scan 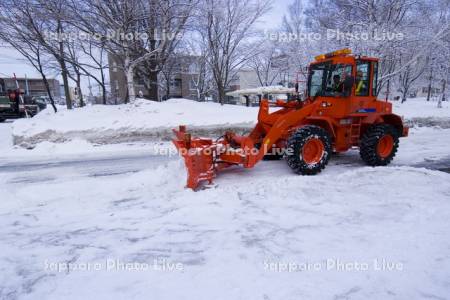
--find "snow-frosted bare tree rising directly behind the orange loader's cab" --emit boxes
[307,0,444,92]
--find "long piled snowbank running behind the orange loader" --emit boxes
[13,99,450,147]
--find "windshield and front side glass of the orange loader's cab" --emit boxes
[308,63,352,97]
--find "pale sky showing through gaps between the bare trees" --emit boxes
[0,0,292,93]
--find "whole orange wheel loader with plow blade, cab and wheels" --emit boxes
[173,49,408,189]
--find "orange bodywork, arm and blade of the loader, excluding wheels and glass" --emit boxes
[173,50,408,189]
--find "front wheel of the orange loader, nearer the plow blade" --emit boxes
[286,125,332,175]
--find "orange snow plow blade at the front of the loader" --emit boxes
[172,126,216,190]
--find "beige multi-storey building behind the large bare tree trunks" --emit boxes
[108,54,198,103]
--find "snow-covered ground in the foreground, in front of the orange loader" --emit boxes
[0,145,450,300]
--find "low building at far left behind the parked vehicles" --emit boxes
[0,78,61,99]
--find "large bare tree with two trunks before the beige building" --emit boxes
[72,0,196,101]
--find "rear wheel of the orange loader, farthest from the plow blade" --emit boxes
[359,124,399,166]
